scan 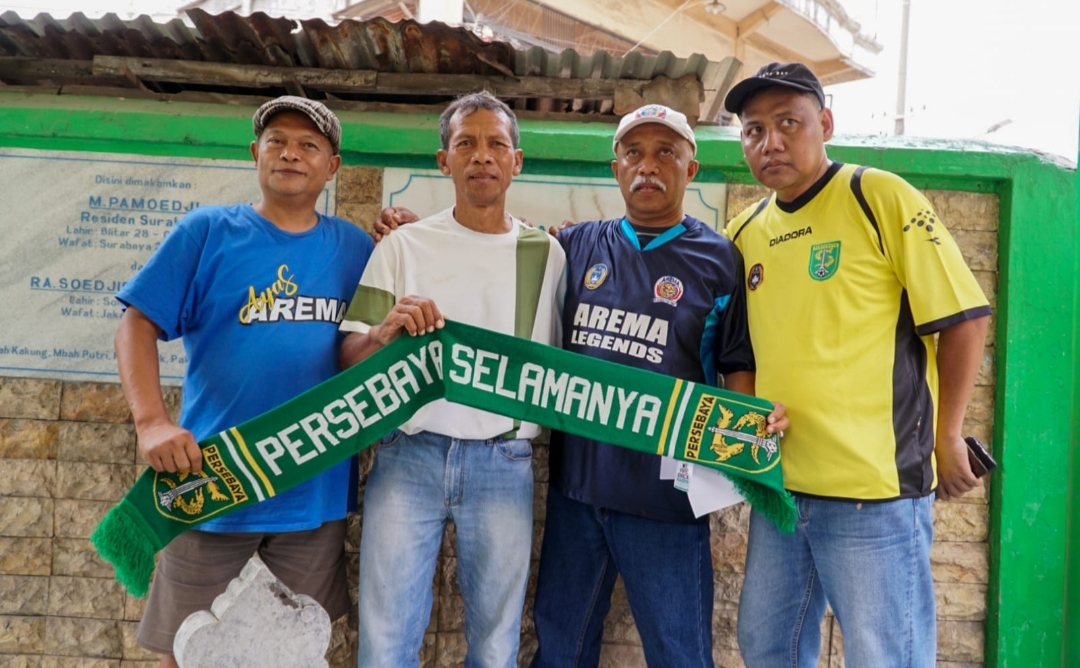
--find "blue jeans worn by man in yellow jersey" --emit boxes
[739,494,937,668]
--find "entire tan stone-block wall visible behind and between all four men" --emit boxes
[0,167,999,668]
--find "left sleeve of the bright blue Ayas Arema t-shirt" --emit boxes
[117,209,211,341]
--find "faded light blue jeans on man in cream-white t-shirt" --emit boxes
[356,431,532,668]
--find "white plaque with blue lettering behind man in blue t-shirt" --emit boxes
[0,148,335,384]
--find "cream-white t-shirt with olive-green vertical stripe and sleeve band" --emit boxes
[341,208,566,439]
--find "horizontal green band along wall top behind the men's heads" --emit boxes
[0,92,1065,186]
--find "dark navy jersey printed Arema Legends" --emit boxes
[551,216,754,522]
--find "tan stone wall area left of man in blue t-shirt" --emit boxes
[0,378,179,668]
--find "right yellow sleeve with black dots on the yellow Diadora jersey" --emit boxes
[856,169,990,336]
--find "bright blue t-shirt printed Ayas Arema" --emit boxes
[117,204,374,532]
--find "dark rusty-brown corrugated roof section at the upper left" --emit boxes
[0,9,513,73]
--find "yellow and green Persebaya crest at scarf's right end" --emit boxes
[686,394,780,471]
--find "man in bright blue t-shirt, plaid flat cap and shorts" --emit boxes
[116,96,373,668]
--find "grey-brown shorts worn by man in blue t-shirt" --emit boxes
[135,519,351,655]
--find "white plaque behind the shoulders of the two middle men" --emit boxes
[382,168,727,230]
